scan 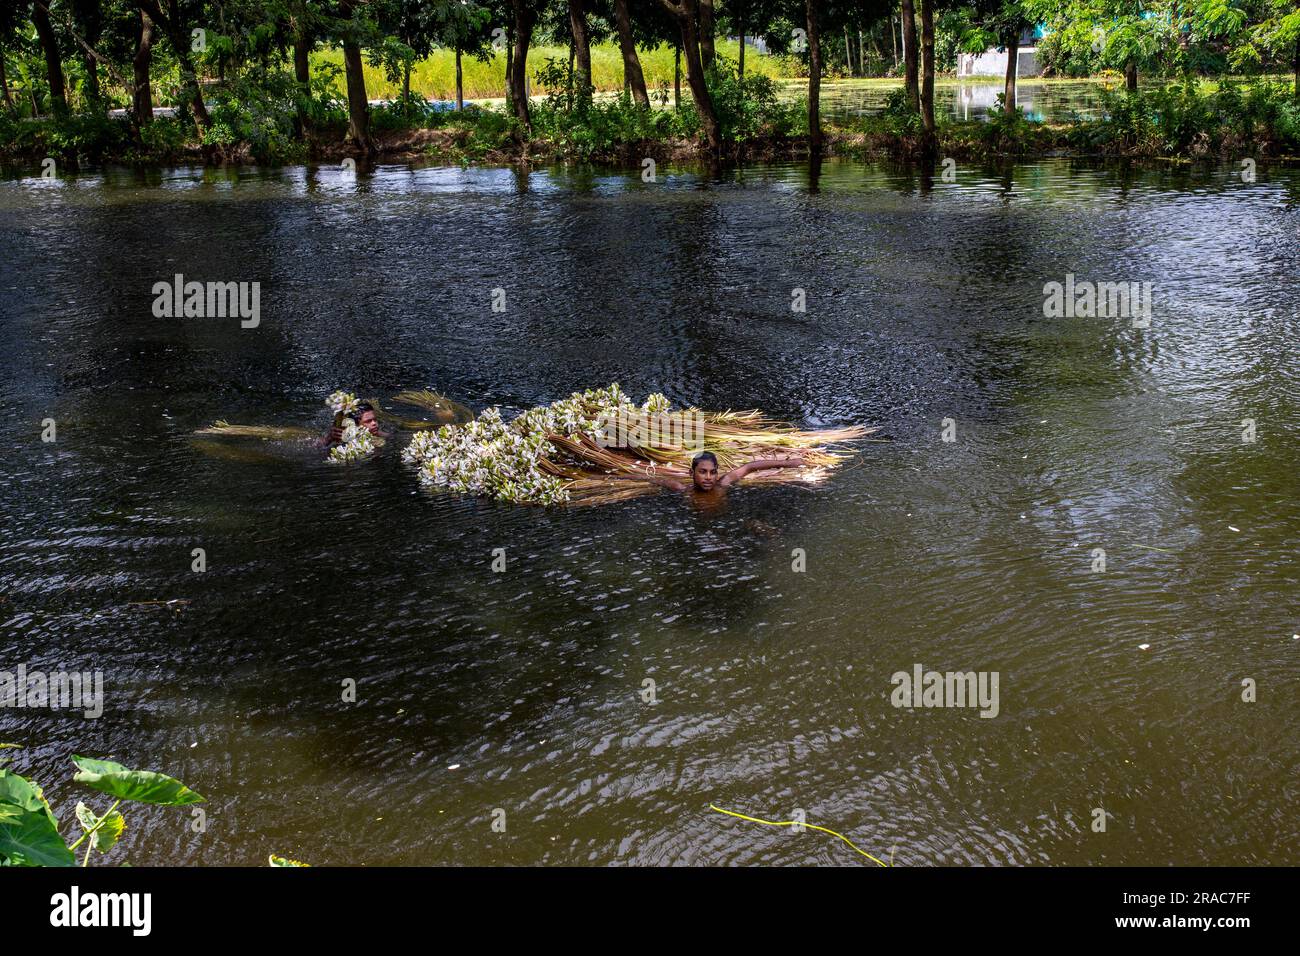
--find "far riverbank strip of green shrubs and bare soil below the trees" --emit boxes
[0,77,1300,168]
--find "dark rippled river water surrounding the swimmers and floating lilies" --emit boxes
[0,160,1300,866]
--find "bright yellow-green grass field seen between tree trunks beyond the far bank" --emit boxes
[312,42,790,100]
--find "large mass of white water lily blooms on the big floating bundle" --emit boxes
[402,384,668,505]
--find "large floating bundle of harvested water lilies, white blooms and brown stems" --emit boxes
[402,384,874,505]
